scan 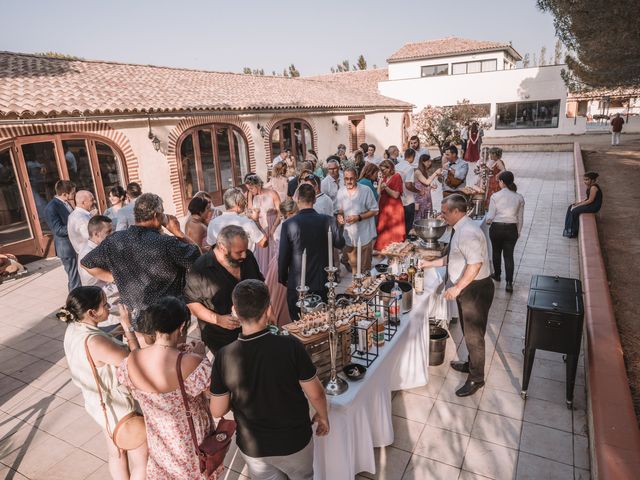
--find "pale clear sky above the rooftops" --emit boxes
[0,0,555,75]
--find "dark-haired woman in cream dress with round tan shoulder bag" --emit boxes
[56,286,147,480]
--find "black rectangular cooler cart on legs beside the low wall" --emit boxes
[520,275,584,408]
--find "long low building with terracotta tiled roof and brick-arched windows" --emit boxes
[0,52,411,256]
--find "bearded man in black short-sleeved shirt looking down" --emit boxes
[184,225,264,354]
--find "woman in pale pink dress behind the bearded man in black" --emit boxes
[245,175,280,275]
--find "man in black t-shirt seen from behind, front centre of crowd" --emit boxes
[211,280,329,480]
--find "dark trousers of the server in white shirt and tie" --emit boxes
[456,277,495,382]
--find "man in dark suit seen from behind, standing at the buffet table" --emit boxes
[278,185,344,320]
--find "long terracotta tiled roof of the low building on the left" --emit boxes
[0,52,411,117]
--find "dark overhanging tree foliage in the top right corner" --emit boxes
[537,0,640,88]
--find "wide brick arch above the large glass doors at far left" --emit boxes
[0,121,140,182]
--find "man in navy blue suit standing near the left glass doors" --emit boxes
[44,180,80,291]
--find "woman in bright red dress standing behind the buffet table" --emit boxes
[374,160,406,251]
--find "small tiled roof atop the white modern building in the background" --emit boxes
[387,37,522,63]
